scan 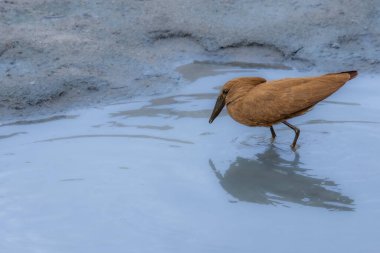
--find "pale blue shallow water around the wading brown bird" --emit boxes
[0,63,380,253]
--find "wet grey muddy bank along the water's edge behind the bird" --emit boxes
[0,0,380,120]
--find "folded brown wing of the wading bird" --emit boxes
[244,73,351,122]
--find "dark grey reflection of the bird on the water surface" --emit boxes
[209,145,354,211]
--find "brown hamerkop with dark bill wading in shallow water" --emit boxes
[209,71,358,149]
